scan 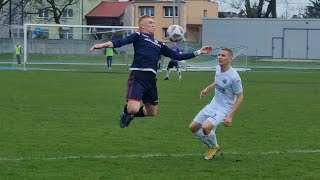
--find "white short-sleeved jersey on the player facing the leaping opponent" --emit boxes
[209,65,243,114]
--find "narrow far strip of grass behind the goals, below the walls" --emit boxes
[0,51,320,69]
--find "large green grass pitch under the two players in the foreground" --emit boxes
[0,67,320,180]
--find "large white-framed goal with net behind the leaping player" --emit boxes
[23,24,137,70]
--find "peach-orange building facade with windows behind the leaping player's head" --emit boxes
[133,0,218,42]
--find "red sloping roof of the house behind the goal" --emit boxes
[86,1,131,17]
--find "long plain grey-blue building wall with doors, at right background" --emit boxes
[203,19,320,59]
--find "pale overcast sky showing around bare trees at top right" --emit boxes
[213,0,310,18]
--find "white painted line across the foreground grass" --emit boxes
[0,149,320,161]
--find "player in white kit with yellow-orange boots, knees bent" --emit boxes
[189,48,243,160]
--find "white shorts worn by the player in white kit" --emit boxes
[194,105,228,127]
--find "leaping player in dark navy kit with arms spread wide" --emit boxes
[89,15,212,128]
